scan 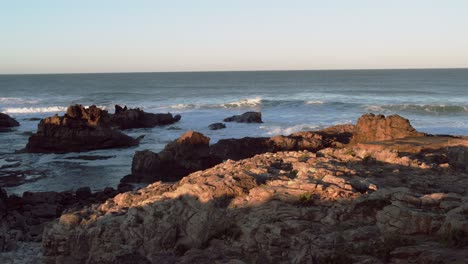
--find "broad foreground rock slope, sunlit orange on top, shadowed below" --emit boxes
[43,144,468,263]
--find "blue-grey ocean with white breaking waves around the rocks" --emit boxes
[0,69,468,194]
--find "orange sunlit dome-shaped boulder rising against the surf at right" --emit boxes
[353,114,425,143]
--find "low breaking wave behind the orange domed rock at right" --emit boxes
[366,104,468,115]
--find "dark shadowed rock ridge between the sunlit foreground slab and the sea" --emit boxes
[122,127,350,183]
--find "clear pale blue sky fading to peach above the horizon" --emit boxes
[0,0,468,74]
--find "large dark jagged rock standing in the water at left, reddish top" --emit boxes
[26,105,138,153]
